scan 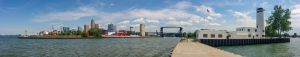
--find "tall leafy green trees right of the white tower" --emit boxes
[266,5,292,38]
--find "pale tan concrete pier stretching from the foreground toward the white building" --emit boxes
[171,39,242,57]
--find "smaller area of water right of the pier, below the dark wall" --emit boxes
[218,38,300,57]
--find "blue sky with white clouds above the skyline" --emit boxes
[0,0,300,35]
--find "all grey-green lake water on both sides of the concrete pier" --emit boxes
[0,36,300,57]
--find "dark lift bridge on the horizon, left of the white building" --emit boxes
[160,27,183,37]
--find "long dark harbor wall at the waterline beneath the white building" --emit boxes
[198,38,290,47]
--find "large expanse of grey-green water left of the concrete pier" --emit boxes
[0,36,180,57]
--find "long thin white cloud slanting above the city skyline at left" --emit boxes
[33,7,97,22]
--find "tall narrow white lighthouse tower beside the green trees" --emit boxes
[256,8,265,38]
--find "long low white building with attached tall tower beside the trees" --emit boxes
[197,8,265,39]
